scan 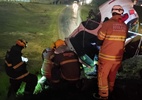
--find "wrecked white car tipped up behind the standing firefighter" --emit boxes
[65,0,141,77]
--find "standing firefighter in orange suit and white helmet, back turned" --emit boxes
[93,5,128,100]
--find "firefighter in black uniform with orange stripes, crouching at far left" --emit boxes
[5,39,37,100]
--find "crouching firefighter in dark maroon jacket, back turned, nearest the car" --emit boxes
[51,39,81,91]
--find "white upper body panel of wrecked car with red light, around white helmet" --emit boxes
[99,0,139,24]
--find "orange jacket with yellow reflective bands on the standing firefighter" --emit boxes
[98,15,128,61]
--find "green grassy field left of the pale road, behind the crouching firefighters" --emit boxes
[0,2,65,100]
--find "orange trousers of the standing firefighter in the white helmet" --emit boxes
[98,60,120,97]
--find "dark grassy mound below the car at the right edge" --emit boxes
[117,55,142,79]
